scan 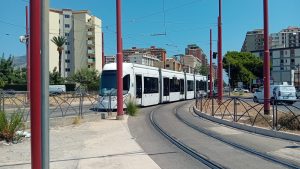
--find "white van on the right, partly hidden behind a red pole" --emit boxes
[253,85,297,104]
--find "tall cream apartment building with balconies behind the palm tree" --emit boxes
[49,9,102,77]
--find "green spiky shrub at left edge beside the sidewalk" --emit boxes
[0,111,23,142]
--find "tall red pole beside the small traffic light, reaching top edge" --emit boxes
[218,0,223,101]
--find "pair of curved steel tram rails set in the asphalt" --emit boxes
[150,102,299,169]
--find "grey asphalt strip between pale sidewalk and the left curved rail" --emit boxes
[128,105,208,169]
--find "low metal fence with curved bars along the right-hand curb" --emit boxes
[196,95,300,133]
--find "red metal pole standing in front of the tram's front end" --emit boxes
[117,0,123,119]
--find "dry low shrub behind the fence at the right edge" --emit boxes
[278,114,300,130]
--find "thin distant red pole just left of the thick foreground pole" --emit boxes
[25,6,30,100]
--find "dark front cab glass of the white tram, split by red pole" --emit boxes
[100,70,130,96]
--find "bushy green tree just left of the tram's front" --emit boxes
[70,68,100,90]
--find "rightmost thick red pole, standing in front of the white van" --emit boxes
[264,0,270,114]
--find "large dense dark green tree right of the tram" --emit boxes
[223,51,263,86]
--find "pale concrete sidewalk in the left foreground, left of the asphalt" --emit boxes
[0,116,160,169]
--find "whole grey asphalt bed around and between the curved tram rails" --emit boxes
[129,102,300,169]
